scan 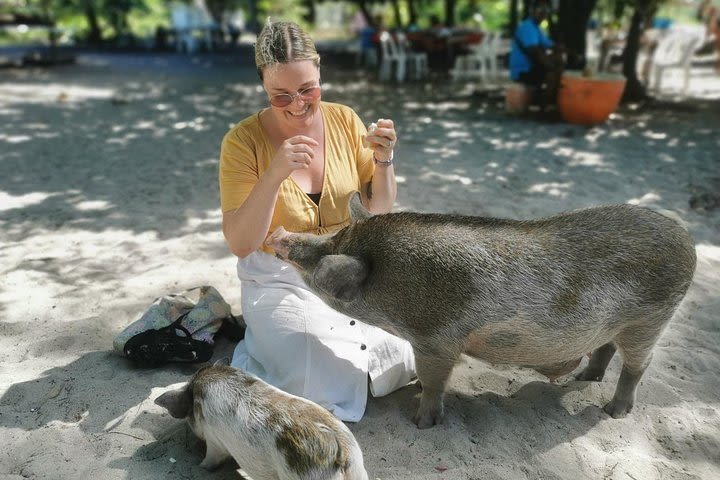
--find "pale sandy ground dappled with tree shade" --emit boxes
[0,52,720,480]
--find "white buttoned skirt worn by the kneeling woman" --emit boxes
[232,251,415,422]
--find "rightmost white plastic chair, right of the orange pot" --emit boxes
[651,31,700,95]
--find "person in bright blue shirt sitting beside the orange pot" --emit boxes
[510,0,564,111]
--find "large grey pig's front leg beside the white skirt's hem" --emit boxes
[413,348,460,428]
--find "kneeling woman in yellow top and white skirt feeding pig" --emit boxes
[219,22,415,421]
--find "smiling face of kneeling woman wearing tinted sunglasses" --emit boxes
[263,60,320,128]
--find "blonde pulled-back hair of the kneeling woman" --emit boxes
[255,18,320,80]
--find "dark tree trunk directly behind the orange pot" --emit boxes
[553,0,597,70]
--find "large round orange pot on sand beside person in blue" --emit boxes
[558,72,625,126]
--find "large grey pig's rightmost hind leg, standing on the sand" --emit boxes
[603,323,664,418]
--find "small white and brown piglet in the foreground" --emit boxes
[155,365,368,480]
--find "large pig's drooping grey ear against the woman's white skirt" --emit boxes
[313,255,368,302]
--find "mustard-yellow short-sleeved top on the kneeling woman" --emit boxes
[219,102,375,253]
